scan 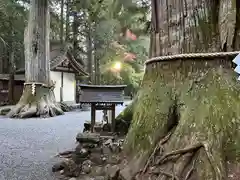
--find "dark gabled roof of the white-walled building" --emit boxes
[16,43,88,76]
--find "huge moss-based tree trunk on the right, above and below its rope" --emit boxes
[120,0,240,180]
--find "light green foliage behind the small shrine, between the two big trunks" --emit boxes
[72,0,149,94]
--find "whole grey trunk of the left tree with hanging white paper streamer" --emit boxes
[8,0,63,118]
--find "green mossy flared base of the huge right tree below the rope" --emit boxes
[125,60,240,180]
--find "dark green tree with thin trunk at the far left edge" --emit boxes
[0,0,26,104]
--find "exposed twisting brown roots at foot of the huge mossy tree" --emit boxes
[140,140,224,180]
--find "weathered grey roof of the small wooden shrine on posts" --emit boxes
[78,84,126,104]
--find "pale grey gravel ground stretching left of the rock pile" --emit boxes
[0,106,127,180]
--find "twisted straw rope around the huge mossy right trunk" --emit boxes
[145,51,240,65]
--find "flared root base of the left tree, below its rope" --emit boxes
[7,85,63,118]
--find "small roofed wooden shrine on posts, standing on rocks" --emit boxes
[79,84,126,132]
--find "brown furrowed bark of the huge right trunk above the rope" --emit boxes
[150,0,224,57]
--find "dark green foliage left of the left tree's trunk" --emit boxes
[0,0,27,69]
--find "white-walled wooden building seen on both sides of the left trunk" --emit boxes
[0,43,88,103]
